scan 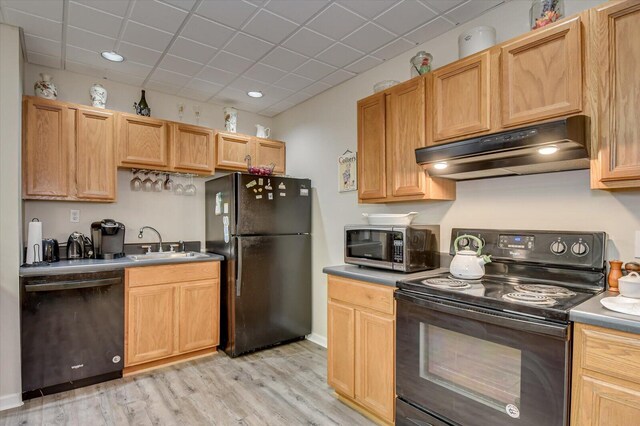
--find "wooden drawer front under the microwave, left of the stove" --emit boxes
[328,275,395,315]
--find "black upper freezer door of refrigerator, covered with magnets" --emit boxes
[236,174,311,235]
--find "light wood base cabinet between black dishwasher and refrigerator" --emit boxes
[125,262,220,374]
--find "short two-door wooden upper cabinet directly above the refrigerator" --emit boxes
[216,132,286,174]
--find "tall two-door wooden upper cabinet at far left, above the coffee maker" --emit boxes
[22,96,116,201]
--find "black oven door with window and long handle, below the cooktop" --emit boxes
[396,291,570,426]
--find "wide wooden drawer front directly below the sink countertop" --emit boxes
[126,262,220,287]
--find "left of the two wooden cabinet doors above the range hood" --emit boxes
[432,51,491,142]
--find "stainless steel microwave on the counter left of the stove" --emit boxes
[344,225,440,272]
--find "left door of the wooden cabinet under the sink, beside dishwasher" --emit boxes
[125,284,177,366]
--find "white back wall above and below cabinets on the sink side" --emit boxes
[24,64,272,243]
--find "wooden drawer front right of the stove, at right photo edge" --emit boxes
[576,324,640,383]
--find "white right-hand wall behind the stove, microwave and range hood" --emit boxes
[274,0,640,338]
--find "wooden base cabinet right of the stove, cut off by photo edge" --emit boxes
[571,323,640,426]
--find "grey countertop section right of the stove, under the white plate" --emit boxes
[569,291,640,334]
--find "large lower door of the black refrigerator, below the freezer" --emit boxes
[227,235,311,356]
